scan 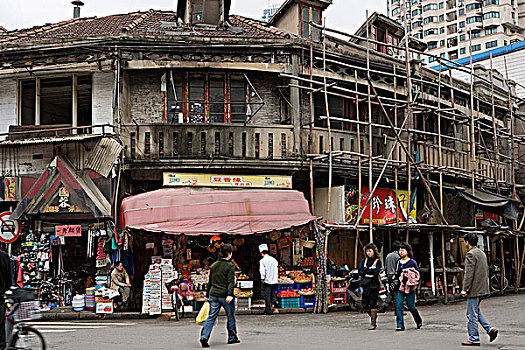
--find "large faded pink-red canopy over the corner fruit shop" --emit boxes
[120,188,316,235]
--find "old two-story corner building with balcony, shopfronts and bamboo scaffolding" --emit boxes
[0,0,522,312]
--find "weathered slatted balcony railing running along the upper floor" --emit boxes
[121,123,508,181]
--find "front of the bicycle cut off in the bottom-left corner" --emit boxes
[5,287,46,350]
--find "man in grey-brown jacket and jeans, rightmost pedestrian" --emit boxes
[461,233,498,346]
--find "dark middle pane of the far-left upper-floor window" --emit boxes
[40,77,73,125]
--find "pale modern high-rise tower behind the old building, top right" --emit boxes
[387,0,525,63]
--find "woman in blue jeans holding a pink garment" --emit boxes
[396,242,423,331]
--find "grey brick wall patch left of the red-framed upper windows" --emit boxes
[130,70,163,123]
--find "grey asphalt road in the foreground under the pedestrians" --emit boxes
[36,294,525,350]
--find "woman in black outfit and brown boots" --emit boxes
[359,243,382,331]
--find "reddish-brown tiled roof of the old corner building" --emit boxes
[0,10,288,43]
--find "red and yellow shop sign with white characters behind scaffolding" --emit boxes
[361,187,416,225]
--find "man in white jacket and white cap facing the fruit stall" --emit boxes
[259,244,279,315]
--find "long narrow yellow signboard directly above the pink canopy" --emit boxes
[163,173,292,188]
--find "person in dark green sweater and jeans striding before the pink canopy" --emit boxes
[200,244,241,348]
